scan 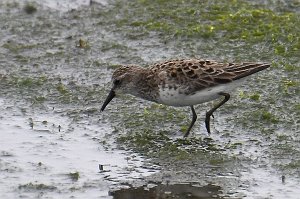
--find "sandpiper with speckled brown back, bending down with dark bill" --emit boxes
[101,59,270,137]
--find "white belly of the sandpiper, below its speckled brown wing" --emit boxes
[158,80,242,106]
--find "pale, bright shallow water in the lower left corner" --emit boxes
[0,99,157,198]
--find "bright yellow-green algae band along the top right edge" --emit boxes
[106,0,300,59]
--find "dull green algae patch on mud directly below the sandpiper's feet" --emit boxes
[117,130,231,165]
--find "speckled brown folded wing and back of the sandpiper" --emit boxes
[152,59,270,93]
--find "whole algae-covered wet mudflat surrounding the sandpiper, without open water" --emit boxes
[0,0,300,196]
